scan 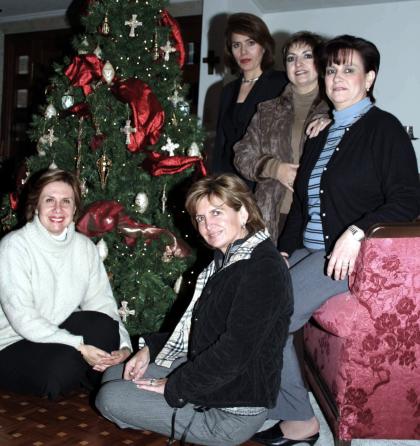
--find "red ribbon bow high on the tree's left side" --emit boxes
[64,54,104,96]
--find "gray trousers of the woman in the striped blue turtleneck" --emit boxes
[268,249,348,421]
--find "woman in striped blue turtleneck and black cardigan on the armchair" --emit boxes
[254,35,420,446]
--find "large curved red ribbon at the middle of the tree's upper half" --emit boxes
[112,79,165,152]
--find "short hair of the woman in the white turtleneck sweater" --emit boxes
[25,169,82,221]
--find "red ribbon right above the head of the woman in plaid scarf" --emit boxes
[143,152,207,177]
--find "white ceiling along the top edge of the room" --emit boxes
[0,0,416,23]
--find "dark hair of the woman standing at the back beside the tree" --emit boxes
[225,12,276,73]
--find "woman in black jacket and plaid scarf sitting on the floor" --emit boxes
[96,174,292,446]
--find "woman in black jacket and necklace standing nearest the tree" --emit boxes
[210,13,287,187]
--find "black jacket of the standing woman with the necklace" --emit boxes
[210,70,288,185]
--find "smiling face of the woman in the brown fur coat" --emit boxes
[286,43,318,94]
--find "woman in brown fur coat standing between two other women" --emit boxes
[234,31,329,243]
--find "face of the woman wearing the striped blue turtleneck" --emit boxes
[325,51,375,110]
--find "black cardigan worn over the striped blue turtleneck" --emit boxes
[279,107,420,254]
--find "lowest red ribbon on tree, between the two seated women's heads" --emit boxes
[77,200,191,259]
